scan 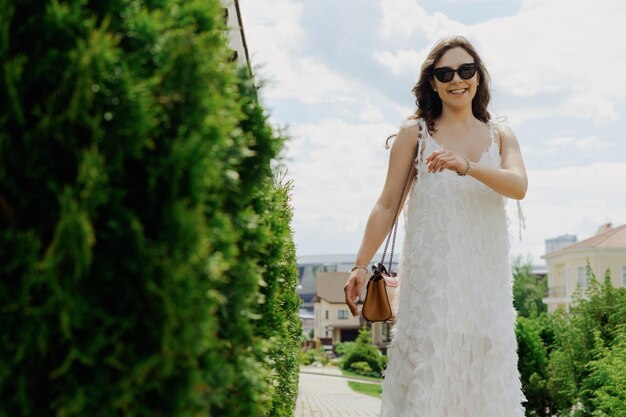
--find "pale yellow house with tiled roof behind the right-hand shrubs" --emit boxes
[543,223,626,312]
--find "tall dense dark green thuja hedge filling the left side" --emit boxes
[0,0,299,416]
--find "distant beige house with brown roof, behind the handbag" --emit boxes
[313,272,389,350]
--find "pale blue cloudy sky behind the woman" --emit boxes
[239,0,626,264]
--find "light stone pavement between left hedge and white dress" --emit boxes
[296,367,380,417]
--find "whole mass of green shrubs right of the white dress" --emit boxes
[516,265,626,417]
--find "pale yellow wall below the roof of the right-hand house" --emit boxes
[543,248,626,312]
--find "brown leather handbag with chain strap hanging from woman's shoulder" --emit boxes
[361,125,422,322]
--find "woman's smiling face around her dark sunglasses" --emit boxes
[431,47,479,109]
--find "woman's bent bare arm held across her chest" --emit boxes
[426,127,528,200]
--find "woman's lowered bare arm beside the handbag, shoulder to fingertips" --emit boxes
[344,125,419,316]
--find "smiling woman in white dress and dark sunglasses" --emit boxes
[344,37,528,417]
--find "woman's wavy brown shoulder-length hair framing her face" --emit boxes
[410,36,491,133]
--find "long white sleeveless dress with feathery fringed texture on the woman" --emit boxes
[381,121,526,417]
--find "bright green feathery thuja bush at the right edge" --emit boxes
[547,266,626,417]
